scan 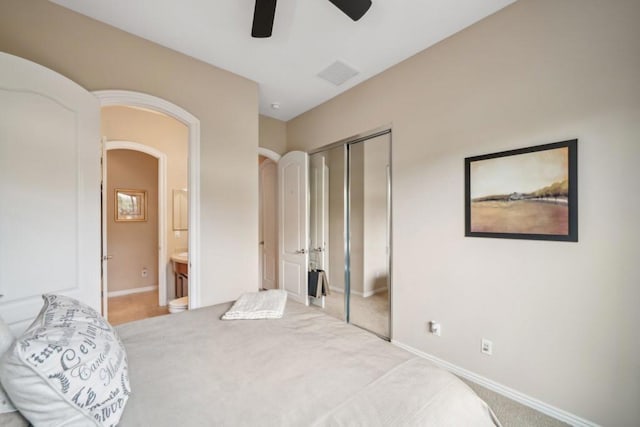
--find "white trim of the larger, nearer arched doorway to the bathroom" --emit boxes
[92,90,201,309]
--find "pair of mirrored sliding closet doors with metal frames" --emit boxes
[309,131,391,338]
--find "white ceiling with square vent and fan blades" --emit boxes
[51,0,515,121]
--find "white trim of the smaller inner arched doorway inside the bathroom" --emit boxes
[103,140,167,306]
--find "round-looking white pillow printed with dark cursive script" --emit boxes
[0,295,130,426]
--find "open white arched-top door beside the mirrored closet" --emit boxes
[278,151,309,305]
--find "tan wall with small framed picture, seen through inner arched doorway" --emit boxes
[107,150,158,292]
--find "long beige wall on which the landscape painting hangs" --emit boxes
[287,0,640,426]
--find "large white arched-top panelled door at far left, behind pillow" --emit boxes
[0,53,100,333]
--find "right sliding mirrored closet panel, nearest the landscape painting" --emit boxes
[347,133,391,338]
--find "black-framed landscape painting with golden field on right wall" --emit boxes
[464,139,578,242]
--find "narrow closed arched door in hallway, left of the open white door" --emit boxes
[260,159,278,289]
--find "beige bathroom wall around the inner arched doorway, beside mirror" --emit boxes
[101,106,189,298]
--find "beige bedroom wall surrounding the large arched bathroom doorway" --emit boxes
[0,0,258,305]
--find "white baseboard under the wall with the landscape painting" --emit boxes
[391,340,598,427]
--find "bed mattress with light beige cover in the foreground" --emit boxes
[117,301,499,427]
